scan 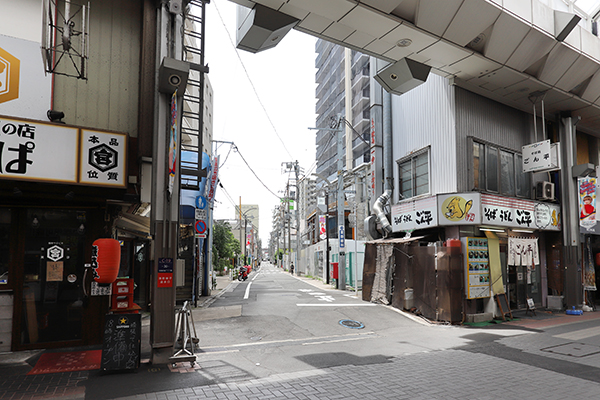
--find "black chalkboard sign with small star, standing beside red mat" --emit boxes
[101,314,142,371]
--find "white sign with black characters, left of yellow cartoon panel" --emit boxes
[391,196,438,232]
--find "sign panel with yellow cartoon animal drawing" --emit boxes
[438,193,481,226]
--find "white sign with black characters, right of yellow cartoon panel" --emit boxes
[481,194,561,231]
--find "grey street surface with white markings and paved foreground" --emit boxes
[85,264,600,399]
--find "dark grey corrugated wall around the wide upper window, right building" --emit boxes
[455,87,528,192]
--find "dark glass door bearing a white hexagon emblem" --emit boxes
[20,209,86,345]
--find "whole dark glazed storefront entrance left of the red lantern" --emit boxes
[0,207,105,350]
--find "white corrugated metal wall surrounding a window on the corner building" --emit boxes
[392,74,457,203]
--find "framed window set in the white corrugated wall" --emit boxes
[398,151,429,200]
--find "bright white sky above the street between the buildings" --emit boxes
[205,0,316,247]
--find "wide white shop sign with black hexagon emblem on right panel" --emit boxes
[0,116,127,187]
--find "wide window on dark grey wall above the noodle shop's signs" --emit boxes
[473,142,531,197]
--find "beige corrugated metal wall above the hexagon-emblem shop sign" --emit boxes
[54,0,142,137]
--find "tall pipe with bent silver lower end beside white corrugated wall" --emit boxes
[373,90,392,237]
